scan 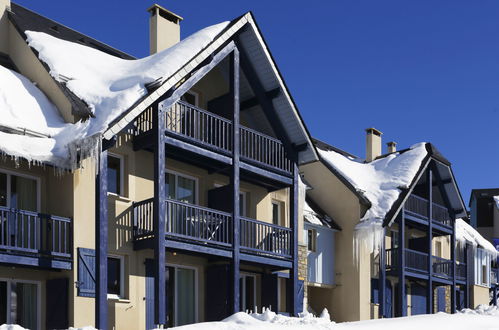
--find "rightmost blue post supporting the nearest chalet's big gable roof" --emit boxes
[289,164,298,316]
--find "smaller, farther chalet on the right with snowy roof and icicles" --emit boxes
[300,128,494,321]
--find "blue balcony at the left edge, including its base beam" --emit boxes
[0,207,72,269]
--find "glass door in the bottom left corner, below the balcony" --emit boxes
[0,280,40,329]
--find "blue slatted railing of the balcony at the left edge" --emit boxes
[0,207,72,258]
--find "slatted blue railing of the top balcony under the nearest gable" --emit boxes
[134,101,293,176]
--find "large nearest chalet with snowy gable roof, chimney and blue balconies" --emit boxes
[0,0,318,329]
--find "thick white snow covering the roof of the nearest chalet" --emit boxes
[0,22,229,167]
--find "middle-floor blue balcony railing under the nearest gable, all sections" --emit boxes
[133,199,292,259]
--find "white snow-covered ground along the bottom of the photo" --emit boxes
[169,306,499,330]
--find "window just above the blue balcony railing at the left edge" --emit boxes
[0,172,40,212]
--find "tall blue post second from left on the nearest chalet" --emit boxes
[153,104,167,327]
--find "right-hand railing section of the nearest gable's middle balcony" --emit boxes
[241,217,292,257]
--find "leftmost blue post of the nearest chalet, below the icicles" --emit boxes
[95,146,108,330]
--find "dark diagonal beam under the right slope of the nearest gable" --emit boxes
[236,36,298,161]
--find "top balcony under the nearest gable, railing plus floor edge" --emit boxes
[134,101,293,188]
